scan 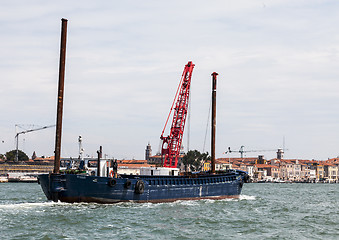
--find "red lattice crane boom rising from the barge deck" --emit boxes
[160,62,195,168]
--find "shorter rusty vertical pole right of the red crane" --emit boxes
[211,72,218,174]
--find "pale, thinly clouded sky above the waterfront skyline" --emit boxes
[0,0,339,160]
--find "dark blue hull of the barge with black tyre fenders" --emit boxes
[38,172,246,203]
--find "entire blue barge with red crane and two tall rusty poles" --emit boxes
[38,19,248,203]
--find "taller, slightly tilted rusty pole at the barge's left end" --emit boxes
[53,18,67,173]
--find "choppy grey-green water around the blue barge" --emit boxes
[0,183,339,239]
